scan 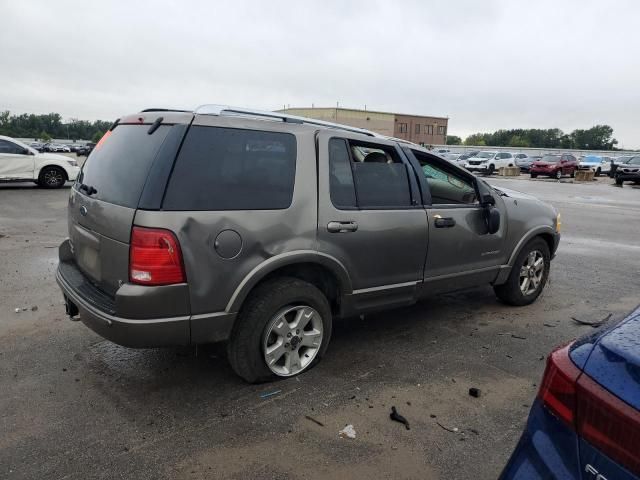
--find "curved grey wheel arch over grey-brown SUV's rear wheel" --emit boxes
[225,251,353,313]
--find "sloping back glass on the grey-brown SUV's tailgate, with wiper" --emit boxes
[77,125,170,208]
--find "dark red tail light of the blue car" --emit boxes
[538,346,640,475]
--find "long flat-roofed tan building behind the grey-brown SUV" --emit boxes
[278,107,449,145]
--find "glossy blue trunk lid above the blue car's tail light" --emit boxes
[584,307,640,410]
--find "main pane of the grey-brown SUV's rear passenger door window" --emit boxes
[349,141,411,208]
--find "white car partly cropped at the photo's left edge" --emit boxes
[0,135,80,188]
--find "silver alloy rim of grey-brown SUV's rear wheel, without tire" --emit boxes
[262,305,324,377]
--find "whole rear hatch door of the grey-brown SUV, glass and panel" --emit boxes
[68,115,182,295]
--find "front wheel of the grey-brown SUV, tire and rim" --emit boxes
[493,238,551,306]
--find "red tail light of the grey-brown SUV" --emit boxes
[129,227,186,285]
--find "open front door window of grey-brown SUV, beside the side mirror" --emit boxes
[413,150,477,205]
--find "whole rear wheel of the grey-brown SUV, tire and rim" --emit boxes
[227,277,332,383]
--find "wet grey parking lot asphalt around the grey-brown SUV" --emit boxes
[0,177,640,479]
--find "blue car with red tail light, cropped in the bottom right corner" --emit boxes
[500,308,640,480]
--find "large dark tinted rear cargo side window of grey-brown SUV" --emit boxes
[162,126,296,210]
